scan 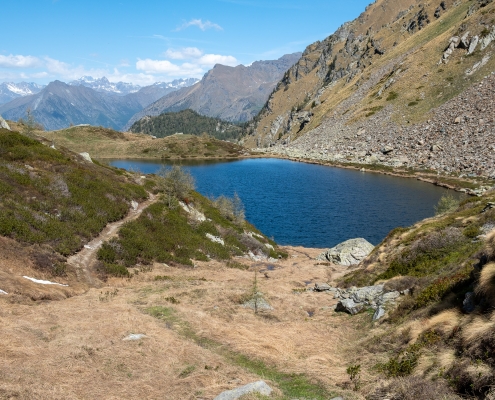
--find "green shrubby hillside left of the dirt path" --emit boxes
[0,130,147,256]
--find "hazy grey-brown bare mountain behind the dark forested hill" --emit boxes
[126,53,301,129]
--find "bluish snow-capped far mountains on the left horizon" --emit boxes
[0,78,201,130]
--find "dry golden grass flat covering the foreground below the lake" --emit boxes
[0,248,361,399]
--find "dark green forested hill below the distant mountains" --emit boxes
[130,110,248,140]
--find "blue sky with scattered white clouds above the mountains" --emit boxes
[0,0,371,85]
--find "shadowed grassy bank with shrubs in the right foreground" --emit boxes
[339,190,495,399]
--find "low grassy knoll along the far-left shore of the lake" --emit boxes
[38,126,252,159]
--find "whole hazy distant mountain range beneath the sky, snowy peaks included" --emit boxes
[0,53,301,130]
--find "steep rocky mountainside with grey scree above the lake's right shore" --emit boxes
[245,0,495,176]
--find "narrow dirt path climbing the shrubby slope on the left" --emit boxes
[67,193,157,286]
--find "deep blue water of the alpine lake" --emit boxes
[110,158,456,248]
